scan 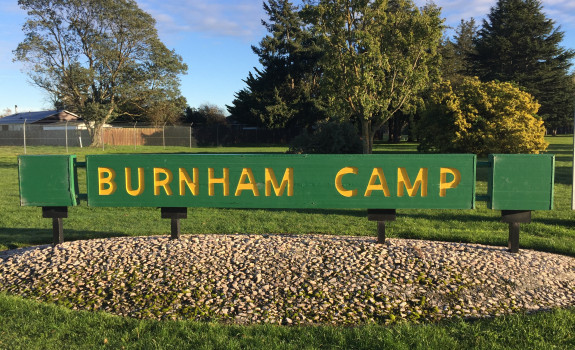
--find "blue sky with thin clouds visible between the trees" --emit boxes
[0,0,575,114]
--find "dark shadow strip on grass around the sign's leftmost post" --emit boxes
[0,228,127,249]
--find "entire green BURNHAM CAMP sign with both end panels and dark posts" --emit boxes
[18,154,555,252]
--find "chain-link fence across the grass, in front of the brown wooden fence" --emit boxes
[0,123,297,152]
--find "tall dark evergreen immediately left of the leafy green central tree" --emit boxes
[227,0,324,128]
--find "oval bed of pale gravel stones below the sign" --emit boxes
[0,234,575,325]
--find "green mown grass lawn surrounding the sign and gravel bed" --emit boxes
[0,137,575,349]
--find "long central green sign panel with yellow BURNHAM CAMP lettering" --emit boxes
[86,154,476,209]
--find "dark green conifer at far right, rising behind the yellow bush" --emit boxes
[472,0,575,135]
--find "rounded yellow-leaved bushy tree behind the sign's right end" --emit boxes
[417,77,547,155]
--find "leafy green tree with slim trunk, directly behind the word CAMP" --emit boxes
[307,0,443,153]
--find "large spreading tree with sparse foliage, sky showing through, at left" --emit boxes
[14,0,187,145]
